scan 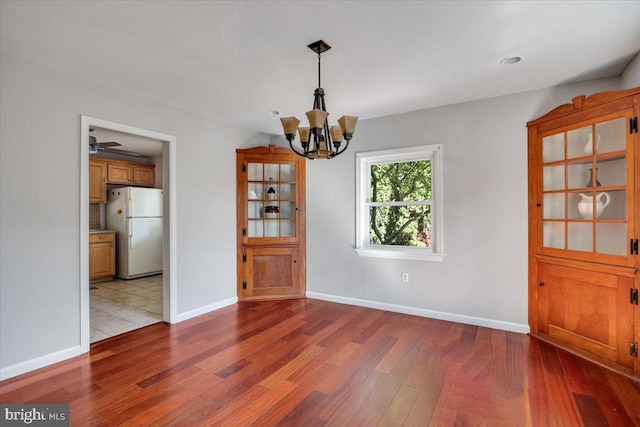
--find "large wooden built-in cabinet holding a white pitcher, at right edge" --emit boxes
[527,88,640,377]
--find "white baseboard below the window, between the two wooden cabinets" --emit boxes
[307,292,530,334]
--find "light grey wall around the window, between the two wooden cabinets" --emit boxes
[307,79,619,332]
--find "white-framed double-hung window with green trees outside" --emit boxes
[355,144,444,261]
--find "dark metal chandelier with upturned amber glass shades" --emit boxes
[280,40,358,159]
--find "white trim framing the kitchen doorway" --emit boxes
[80,115,178,353]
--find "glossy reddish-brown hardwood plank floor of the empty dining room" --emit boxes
[0,299,640,426]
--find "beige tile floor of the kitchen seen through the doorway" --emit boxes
[89,274,162,343]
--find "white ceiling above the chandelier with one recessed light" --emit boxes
[0,0,640,148]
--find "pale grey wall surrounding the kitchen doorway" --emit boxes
[0,55,267,373]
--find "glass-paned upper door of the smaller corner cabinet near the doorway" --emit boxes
[247,163,297,238]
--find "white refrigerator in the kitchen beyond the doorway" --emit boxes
[107,187,162,279]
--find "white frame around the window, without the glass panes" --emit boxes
[354,144,445,261]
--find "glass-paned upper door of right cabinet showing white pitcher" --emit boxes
[542,116,631,259]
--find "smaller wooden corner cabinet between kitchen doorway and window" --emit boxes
[236,145,306,301]
